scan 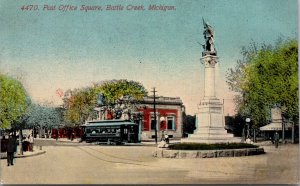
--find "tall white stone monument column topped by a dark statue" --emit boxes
[181,20,241,144]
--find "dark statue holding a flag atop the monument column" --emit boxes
[202,18,217,56]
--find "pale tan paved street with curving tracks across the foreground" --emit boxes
[1,144,299,184]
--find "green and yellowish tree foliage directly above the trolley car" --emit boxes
[64,80,147,125]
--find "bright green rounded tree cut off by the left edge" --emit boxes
[0,74,29,129]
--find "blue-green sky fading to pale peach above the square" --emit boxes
[0,0,298,115]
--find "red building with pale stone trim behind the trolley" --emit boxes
[90,96,185,140]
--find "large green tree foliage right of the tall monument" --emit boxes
[227,40,299,126]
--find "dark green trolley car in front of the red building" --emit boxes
[81,120,139,144]
